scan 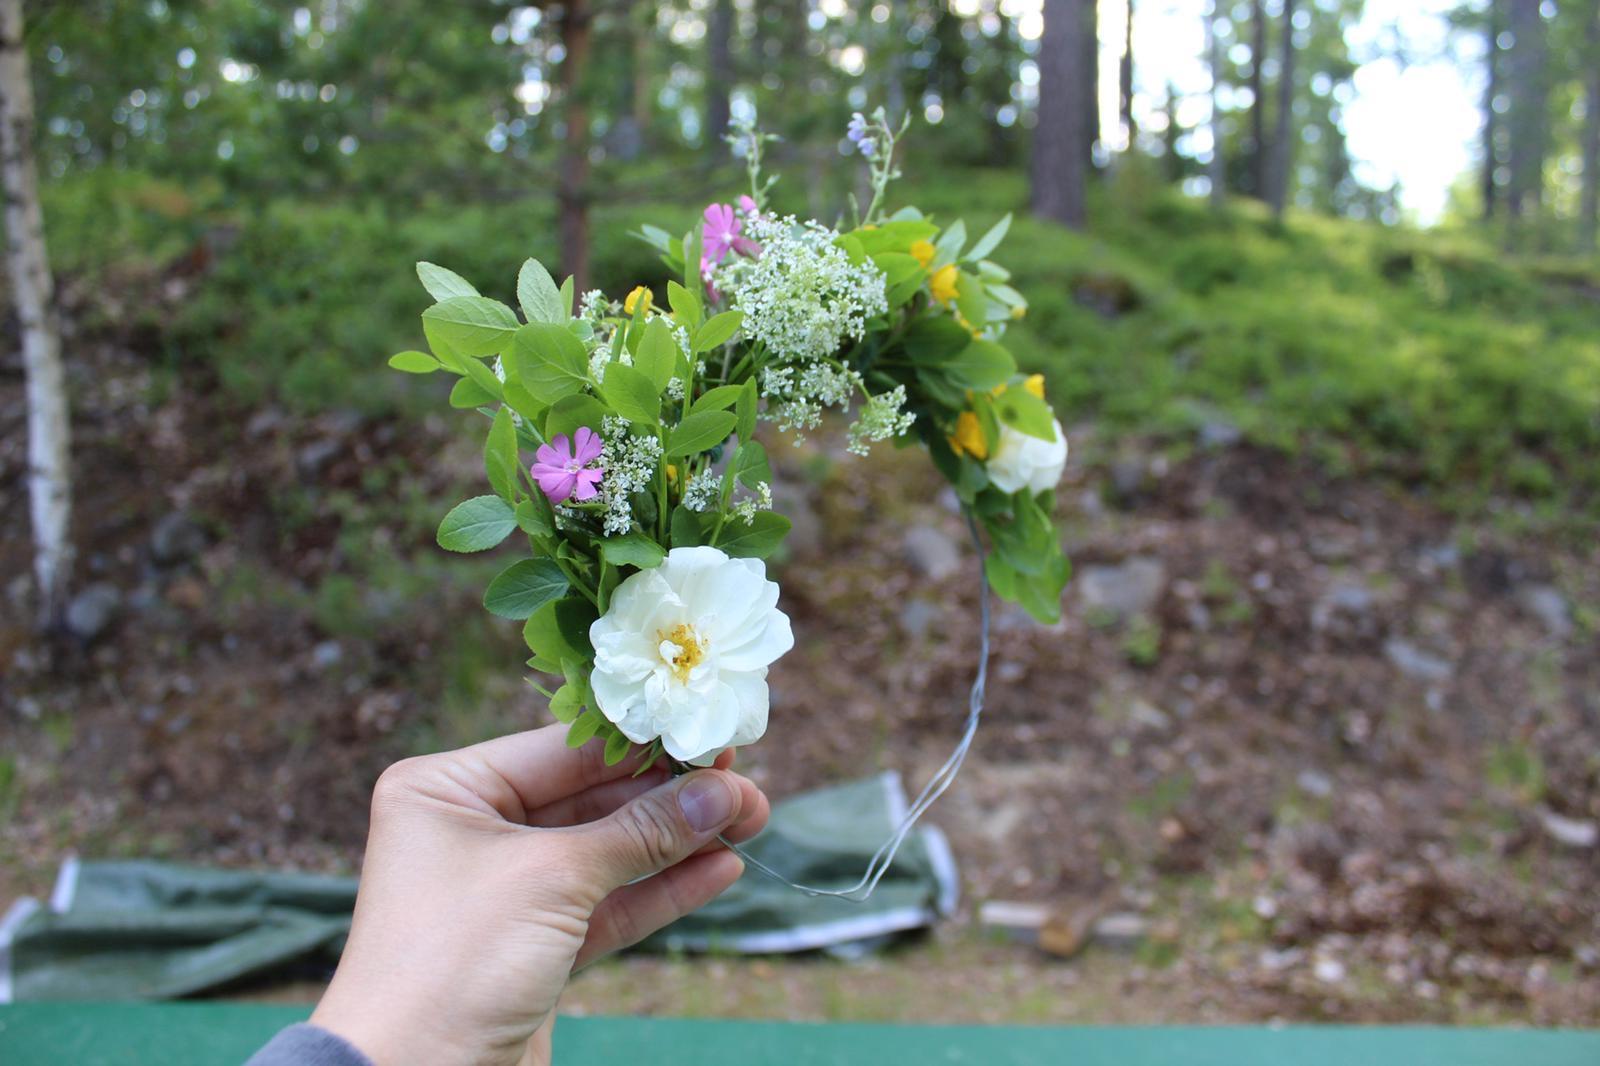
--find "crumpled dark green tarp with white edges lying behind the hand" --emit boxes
[0,775,957,1004]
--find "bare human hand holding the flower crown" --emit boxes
[310,725,768,1066]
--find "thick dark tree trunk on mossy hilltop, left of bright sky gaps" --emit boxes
[1032,0,1091,229]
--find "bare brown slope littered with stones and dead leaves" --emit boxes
[0,334,1600,1026]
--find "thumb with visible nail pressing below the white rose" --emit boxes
[578,770,744,895]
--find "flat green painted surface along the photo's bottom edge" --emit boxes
[0,1004,1600,1066]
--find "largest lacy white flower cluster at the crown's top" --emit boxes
[714,214,888,363]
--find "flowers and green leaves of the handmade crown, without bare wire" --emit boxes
[389,109,1069,767]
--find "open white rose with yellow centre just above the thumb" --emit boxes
[589,547,794,765]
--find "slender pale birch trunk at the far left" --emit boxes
[0,0,74,627]
